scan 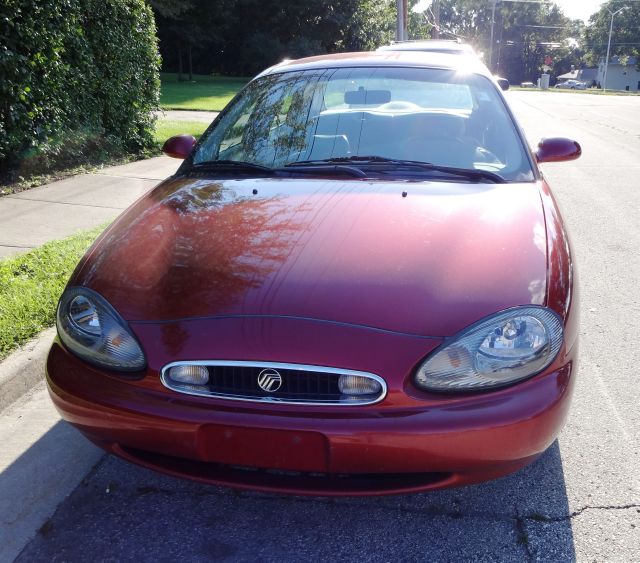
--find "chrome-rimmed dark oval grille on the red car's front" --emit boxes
[161,360,387,406]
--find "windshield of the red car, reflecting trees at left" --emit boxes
[193,67,534,181]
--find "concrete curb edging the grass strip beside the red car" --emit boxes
[0,327,56,411]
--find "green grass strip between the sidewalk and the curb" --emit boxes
[0,225,106,359]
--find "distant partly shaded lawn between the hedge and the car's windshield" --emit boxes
[160,72,250,111]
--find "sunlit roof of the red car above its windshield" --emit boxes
[258,51,491,78]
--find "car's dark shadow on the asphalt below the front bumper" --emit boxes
[16,436,575,562]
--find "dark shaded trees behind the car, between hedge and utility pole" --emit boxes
[151,0,395,76]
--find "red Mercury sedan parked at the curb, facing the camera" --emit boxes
[47,52,580,495]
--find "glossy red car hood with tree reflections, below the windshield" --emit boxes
[71,178,547,336]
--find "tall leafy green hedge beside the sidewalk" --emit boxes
[0,0,159,177]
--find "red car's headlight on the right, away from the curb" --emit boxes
[415,306,563,392]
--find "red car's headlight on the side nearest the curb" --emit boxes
[56,287,146,371]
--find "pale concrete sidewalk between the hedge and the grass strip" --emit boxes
[0,156,181,258]
